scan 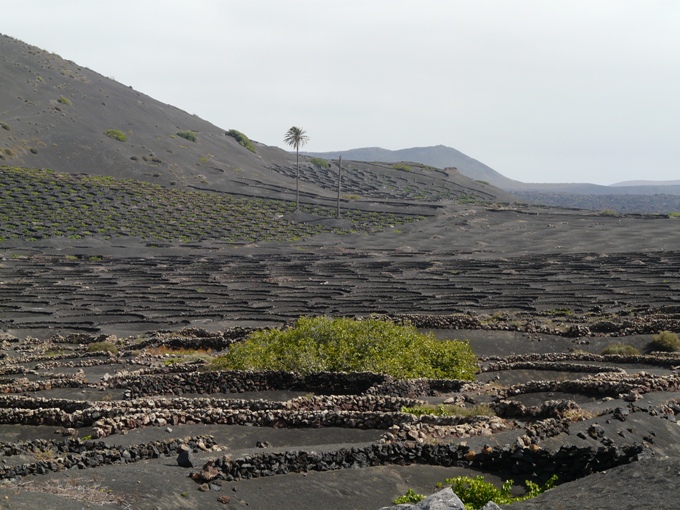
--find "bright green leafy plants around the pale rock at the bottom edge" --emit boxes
[394,475,557,510]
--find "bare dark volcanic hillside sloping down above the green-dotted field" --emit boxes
[0,36,510,209]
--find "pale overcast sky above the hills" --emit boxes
[0,0,680,184]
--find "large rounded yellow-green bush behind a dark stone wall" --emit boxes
[212,317,477,380]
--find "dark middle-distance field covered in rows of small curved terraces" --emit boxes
[0,248,680,337]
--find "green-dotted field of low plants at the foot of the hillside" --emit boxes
[0,166,423,244]
